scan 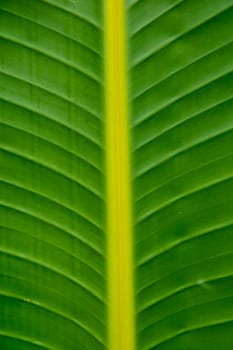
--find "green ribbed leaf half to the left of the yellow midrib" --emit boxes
[0,0,106,350]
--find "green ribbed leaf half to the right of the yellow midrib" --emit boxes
[128,0,233,350]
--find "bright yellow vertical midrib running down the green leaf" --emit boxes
[105,0,135,350]
